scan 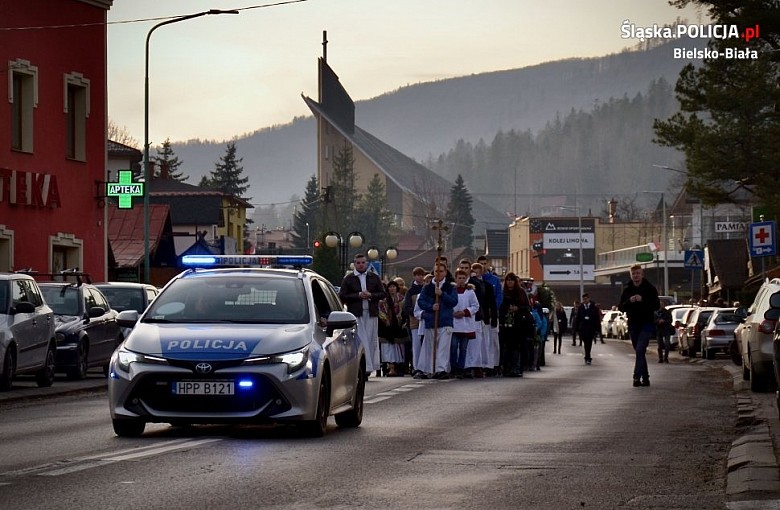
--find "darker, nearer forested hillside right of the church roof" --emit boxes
[425,78,680,215]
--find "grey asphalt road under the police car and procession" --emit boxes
[0,341,780,509]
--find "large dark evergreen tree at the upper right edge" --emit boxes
[653,0,780,215]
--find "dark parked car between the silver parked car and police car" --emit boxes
[38,282,124,379]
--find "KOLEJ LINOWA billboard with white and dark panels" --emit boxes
[530,218,596,282]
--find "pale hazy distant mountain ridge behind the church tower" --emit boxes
[173,40,700,213]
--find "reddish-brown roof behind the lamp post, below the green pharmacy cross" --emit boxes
[108,204,170,267]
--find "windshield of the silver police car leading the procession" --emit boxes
[143,275,309,324]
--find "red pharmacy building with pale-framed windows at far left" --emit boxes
[0,0,112,280]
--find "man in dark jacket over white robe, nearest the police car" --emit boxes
[339,253,385,377]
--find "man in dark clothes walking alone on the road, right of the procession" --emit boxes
[618,264,661,387]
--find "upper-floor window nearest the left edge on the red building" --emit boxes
[8,59,38,152]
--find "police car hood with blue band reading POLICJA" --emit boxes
[125,322,312,360]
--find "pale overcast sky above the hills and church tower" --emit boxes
[108,0,701,145]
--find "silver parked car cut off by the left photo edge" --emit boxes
[0,273,57,390]
